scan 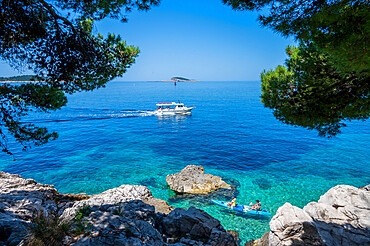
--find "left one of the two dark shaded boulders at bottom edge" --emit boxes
[71,200,164,246]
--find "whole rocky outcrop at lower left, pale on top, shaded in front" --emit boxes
[0,173,236,246]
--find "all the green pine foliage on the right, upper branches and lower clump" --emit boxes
[224,0,370,136]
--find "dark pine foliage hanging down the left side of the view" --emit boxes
[0,0,159,153]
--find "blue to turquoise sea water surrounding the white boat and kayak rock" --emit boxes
[0,81,370,241]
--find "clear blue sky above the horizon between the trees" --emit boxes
[0,0,294,81]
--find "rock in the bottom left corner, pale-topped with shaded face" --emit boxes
[0,172,87,245]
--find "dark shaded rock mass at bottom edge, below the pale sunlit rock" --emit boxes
[67,200,237,246]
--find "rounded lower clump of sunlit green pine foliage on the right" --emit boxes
[261,45,370,137]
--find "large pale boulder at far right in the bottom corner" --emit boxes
[303,185,370,245]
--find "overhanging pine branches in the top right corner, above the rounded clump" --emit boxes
[223,0,370,77]
